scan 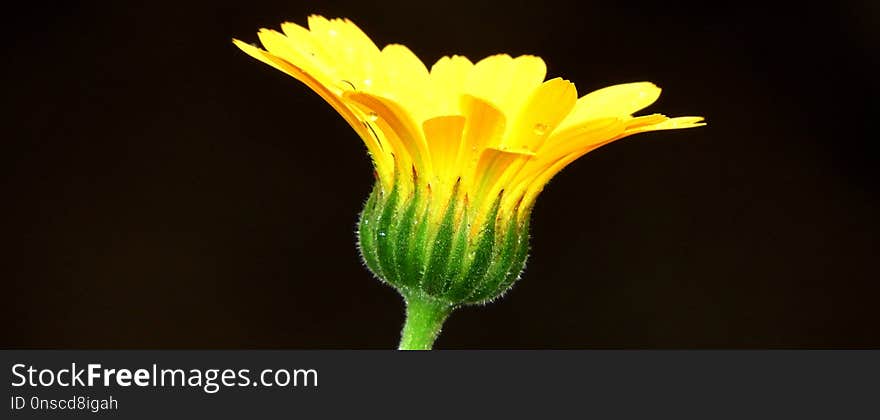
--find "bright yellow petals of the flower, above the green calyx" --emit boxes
[234,16,703,230]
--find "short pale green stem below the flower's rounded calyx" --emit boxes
[399,293,453,350]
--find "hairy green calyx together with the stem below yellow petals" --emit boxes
[358,176,529,349]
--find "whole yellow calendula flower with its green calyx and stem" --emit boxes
[234,16,703,349]
